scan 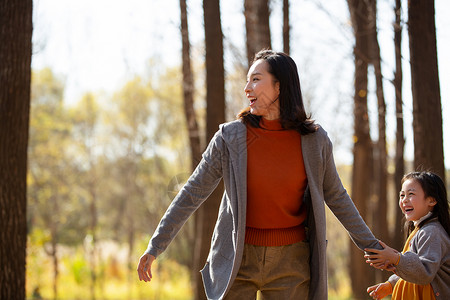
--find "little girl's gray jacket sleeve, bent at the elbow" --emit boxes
[396,226,448,285]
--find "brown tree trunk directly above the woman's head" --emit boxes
[244,0,271,66]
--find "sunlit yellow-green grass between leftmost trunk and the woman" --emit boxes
[26,240,192,300]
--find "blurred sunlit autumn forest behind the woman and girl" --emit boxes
[0,0,450,300]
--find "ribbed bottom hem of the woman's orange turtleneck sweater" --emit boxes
[245,224,306,247]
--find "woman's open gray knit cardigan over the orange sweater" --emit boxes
[146,120,380,300]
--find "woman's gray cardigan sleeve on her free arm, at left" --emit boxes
[145,130,224,257]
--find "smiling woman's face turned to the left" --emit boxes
[244,60,280,120]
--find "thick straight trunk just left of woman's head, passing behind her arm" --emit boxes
[195,0,225,299]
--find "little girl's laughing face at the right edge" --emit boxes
[399,179,436,221]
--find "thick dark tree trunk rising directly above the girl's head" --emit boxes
[408,0,445,181]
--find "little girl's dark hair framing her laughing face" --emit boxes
[402,172,450,235]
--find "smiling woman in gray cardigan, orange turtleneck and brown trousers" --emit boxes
[137,50,381,300]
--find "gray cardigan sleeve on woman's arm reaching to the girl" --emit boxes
[323,136,383,250]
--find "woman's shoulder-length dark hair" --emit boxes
[238,50,318,135]
